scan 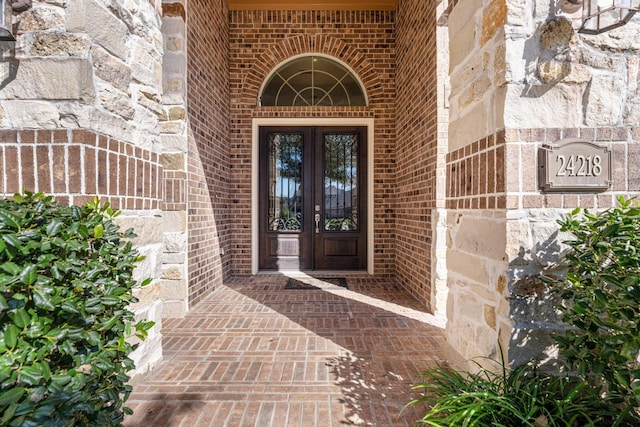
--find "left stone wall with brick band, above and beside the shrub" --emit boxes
[0,0,164,373]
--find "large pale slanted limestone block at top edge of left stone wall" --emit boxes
[66,0,129,60]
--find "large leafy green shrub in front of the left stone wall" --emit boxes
[0,193,153,427]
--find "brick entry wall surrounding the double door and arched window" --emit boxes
[230,11,396,275]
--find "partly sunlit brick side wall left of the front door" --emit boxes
[186,0,231,306]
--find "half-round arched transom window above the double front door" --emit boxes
[260,56,367,107]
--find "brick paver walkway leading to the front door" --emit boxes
[125,274,444,427]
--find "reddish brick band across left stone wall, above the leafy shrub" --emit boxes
[0,129,163,209]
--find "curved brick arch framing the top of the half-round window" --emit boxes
[242,34,383,105]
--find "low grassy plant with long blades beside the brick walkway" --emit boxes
[409,354,632,427]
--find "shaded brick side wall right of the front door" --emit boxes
[395,0,438,304]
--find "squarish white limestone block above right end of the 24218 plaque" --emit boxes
[585,75,626,126]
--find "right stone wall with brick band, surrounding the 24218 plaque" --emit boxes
[447,0,640,372]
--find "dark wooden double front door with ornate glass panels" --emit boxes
[258,127,367,270]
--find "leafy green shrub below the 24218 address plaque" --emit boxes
[552,198,640,418]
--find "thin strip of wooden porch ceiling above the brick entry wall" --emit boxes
[228,0,396,10]
